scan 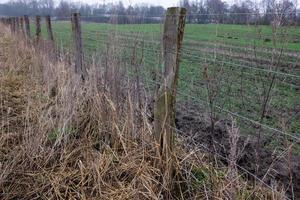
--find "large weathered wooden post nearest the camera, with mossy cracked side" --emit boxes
[154,7,186,192]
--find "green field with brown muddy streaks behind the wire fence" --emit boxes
[32,22,300,151]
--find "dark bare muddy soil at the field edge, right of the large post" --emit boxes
[176,103,300,199]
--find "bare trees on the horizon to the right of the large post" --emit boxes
[180,0,300,25]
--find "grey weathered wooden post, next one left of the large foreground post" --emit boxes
[71,13,87,80]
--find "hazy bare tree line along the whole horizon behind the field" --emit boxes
[0,0,300,24]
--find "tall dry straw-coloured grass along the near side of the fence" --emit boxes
[0,27,281,199]
